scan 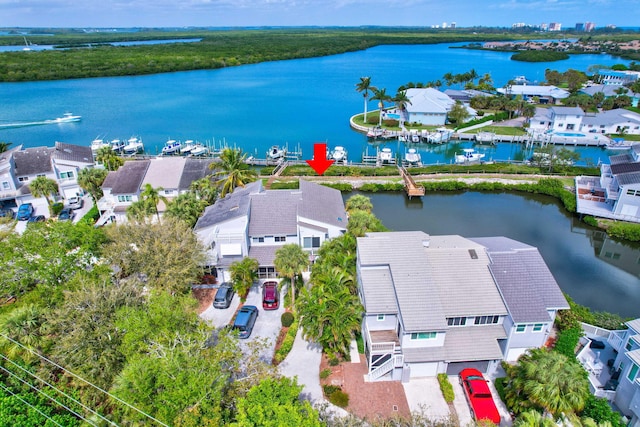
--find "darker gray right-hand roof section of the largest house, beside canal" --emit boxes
[471,237,569,323]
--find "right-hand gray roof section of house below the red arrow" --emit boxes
[298,179,347,229]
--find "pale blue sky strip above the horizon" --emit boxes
[0,0,640,28]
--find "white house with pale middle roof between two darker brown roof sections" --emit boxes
[98,157,212,225]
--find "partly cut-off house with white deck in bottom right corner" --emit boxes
[577,319,640,427]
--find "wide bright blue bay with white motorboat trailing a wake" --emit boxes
[0,44,628,164]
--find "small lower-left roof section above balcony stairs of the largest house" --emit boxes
[360,267,398,314]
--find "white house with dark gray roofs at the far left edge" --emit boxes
[0,142,94,210]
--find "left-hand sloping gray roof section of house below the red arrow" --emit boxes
[194,181,262,230]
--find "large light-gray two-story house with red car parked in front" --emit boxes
[357,231,569,381]
